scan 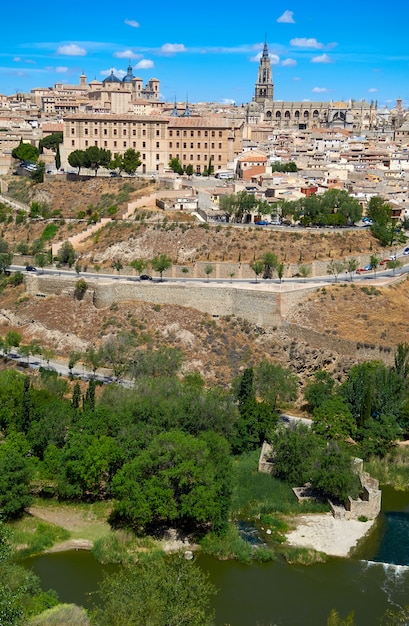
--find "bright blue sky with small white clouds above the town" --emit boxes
[0,0,409,107]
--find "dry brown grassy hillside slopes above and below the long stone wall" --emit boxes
[0,172,409,384]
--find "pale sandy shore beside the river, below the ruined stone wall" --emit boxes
[287,513,376,557]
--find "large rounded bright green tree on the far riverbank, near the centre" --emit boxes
[111,430,231,529]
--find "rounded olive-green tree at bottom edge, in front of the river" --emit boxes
[92,555,216,626]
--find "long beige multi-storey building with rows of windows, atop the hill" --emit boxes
[62,113,243,173]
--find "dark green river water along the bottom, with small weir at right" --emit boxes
[23,488,409,626]
